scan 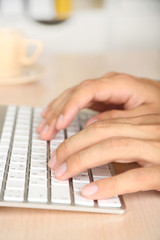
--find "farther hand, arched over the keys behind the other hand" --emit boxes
[37,73,160,140]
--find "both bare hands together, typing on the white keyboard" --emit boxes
[37,73,160,199]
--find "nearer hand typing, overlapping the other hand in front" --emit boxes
[49,114,160,199]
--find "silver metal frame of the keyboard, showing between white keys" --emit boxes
[0,105,126,214]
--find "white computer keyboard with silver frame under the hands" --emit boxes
[0,106,125,214]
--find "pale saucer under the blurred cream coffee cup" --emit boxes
[0,66,43,85]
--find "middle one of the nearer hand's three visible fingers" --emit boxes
[51,137,160,180]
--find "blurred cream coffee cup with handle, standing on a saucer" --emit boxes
[0,29,43,78]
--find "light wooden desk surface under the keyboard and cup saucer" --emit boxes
[0,52,160,240]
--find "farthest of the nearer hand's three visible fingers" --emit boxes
[49,117,160,169]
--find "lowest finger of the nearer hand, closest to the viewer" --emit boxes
[81,166,160,199]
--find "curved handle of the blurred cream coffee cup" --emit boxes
[22,39,43,66]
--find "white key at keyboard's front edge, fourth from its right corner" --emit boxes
[28,185,48,202]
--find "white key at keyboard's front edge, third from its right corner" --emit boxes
[51,185,71,204]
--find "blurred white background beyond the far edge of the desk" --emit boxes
[0,0,160,54]
